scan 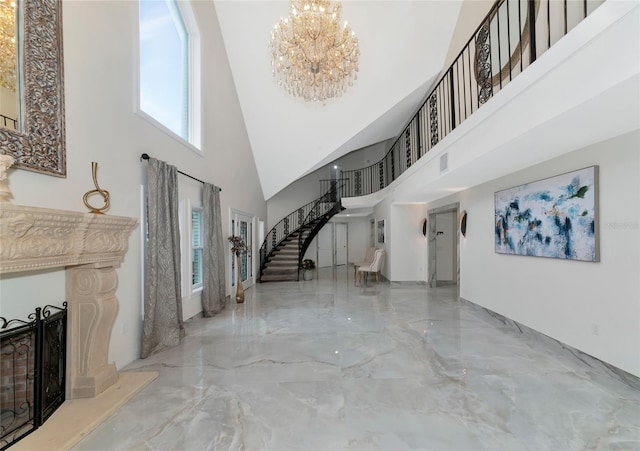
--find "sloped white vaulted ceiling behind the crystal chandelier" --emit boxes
[214,0,462,199]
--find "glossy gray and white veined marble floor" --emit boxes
[73,267,640,451]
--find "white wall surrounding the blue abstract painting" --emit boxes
[429,131,640,376]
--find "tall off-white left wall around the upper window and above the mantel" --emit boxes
[0,0,266,367]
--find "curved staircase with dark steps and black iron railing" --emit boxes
[260,185,344,282]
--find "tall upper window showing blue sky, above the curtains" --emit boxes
[138,0,200,150]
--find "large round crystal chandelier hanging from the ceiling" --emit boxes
[271,0,360,101]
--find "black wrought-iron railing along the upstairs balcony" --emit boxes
[342,0,604,197]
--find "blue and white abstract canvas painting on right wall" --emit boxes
[495,166,599,262]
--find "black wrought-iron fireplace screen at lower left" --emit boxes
[0,302,67,449]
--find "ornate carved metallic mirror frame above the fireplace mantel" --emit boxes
[0,0,67,177]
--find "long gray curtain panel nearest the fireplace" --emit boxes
[140,158,184,358]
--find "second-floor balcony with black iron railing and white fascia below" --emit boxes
[312,0,640,208]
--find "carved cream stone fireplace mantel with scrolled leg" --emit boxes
[0,202,137,399]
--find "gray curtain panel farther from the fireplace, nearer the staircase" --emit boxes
[202,183,226,317]
